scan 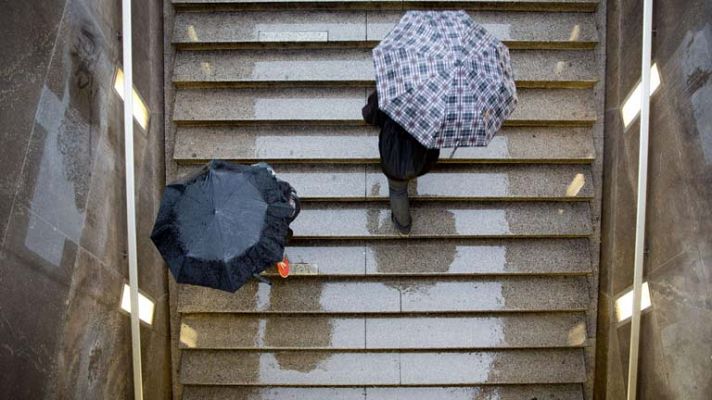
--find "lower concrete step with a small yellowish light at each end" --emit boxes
[180,313,586,351]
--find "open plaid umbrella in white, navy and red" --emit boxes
[373,11,517,148]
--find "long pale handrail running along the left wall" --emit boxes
[121,0,143,400]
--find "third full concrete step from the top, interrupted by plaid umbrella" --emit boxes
[173,88,596,126]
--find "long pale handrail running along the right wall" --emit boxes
[627,0,653,400]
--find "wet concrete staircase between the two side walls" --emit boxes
[165,0,604,400]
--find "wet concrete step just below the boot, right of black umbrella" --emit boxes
[266,239,591,278]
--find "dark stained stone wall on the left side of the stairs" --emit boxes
[0,0,171,400]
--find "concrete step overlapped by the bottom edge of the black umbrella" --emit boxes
[178,276,589,314]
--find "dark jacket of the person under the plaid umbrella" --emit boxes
[361,92,440,181]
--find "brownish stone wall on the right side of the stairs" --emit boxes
[596,0,712,400]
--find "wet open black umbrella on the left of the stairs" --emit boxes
[151,160,299,292]
